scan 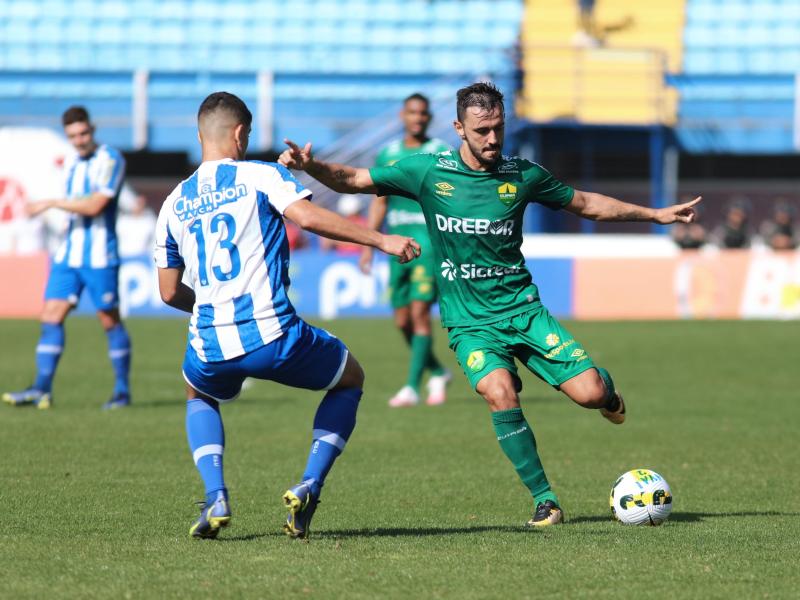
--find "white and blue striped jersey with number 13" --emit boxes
[155,159,311,362]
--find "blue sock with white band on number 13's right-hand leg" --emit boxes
[303,388,363,496]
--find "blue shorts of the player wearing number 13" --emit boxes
[183,318,348,402]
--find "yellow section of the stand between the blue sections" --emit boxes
[519,0,684,125]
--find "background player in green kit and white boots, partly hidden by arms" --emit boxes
[359,94,452,407]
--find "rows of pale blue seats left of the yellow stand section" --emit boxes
[0,0,523,73]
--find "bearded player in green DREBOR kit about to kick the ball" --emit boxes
[279,83,700,527]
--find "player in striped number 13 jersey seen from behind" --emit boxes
[155,92,419,538]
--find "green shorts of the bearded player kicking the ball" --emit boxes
[448,306,594,390]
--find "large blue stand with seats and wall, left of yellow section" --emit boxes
[0,0,523,155]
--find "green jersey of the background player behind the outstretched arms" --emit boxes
[375,138,449,238]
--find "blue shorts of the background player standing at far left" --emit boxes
[44,265,119,310]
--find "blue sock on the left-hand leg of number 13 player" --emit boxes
[186,398,228,505]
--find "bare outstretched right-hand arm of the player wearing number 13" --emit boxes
[283,201,421,263]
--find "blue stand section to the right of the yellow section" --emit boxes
[674,0,800,153]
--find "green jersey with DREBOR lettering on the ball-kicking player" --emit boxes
[370,151,574,327]
